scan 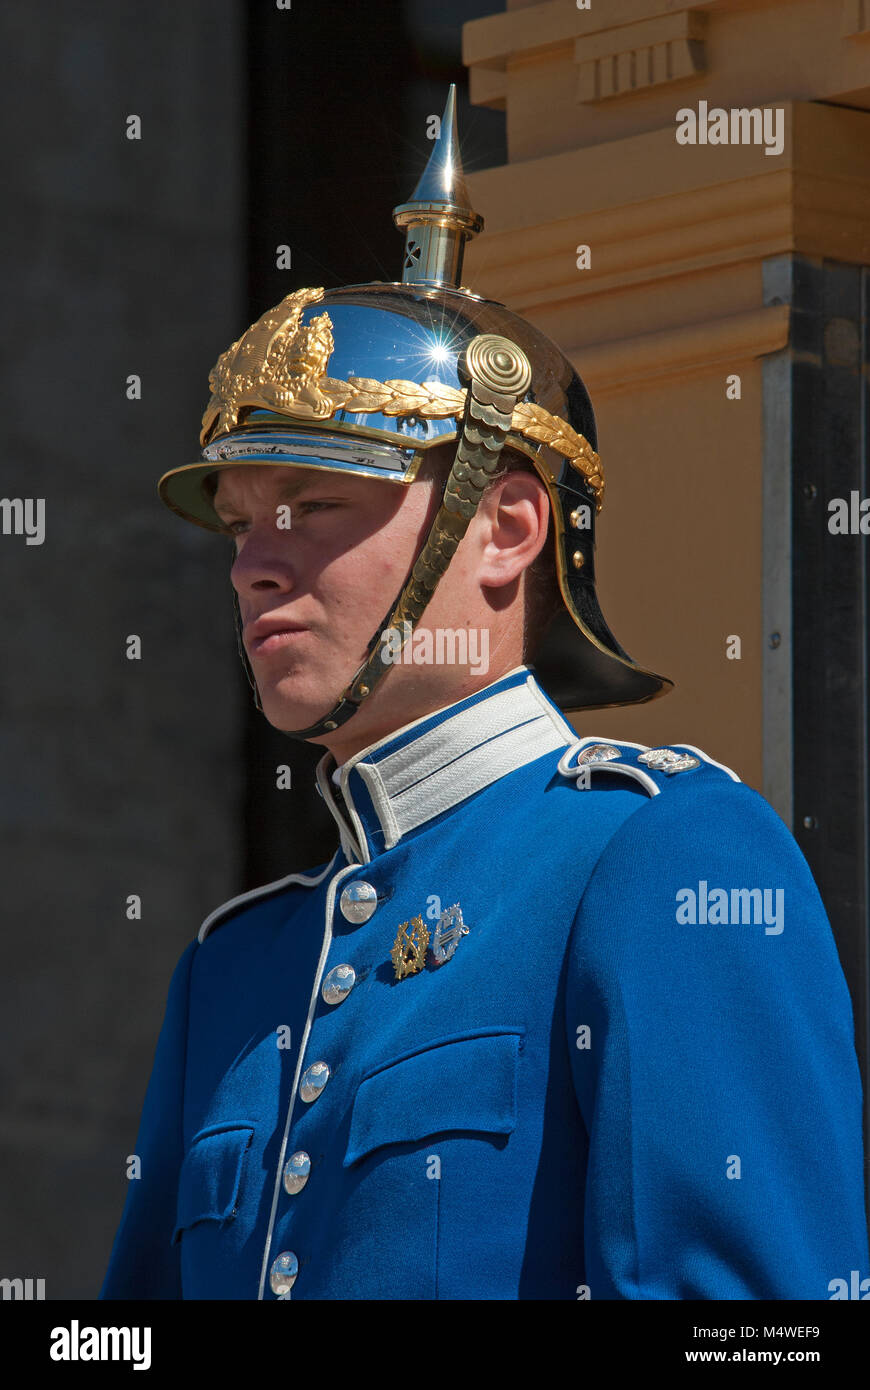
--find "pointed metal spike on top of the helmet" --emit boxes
[393,82,484,289]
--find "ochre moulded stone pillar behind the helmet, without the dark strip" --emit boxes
[463,0,870,821]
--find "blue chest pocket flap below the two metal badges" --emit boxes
[343,1027,524,1168]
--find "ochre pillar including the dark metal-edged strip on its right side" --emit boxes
[464,0,870,1206]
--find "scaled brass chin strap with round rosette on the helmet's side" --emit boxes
[235,334,532,739]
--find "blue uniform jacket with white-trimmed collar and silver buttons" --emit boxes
[101,666,870,1300]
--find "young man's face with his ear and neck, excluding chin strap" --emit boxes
[214,453,546,762]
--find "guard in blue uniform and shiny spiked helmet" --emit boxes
[101,89,870,1300]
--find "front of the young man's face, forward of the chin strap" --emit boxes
[214,466,461,756]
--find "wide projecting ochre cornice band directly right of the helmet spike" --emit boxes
[466,103,870,314]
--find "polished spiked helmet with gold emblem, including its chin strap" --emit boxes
[158,86,671,738]
